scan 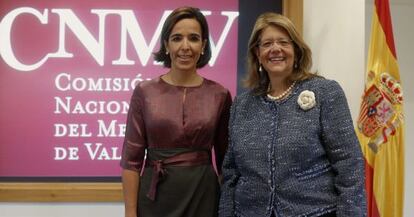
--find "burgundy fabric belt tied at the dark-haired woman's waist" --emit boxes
[146,151,211,201]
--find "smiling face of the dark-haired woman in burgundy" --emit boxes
[164,19,206,71]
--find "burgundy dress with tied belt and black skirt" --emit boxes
[121,77,232,217]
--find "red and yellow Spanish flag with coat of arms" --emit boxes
[356,0,404,217]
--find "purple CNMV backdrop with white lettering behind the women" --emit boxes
[0,0,238,177]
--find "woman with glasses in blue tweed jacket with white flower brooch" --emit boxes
[219,13,366,217]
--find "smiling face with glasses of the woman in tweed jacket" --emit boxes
[257,26,295,78]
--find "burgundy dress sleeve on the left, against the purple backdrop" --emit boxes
[121,85,147,172]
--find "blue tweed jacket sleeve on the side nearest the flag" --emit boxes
[321,81,366,217]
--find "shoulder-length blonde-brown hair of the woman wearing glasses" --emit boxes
[244,12,318,95]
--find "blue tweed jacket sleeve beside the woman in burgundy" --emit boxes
[219,96,240,217]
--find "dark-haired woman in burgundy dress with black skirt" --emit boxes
[121,7,231,217]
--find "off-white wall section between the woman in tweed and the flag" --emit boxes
[303,0,365,119]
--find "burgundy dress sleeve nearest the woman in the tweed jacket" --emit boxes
[214,91,232,174]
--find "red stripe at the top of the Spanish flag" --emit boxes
[375,0,397,59]
